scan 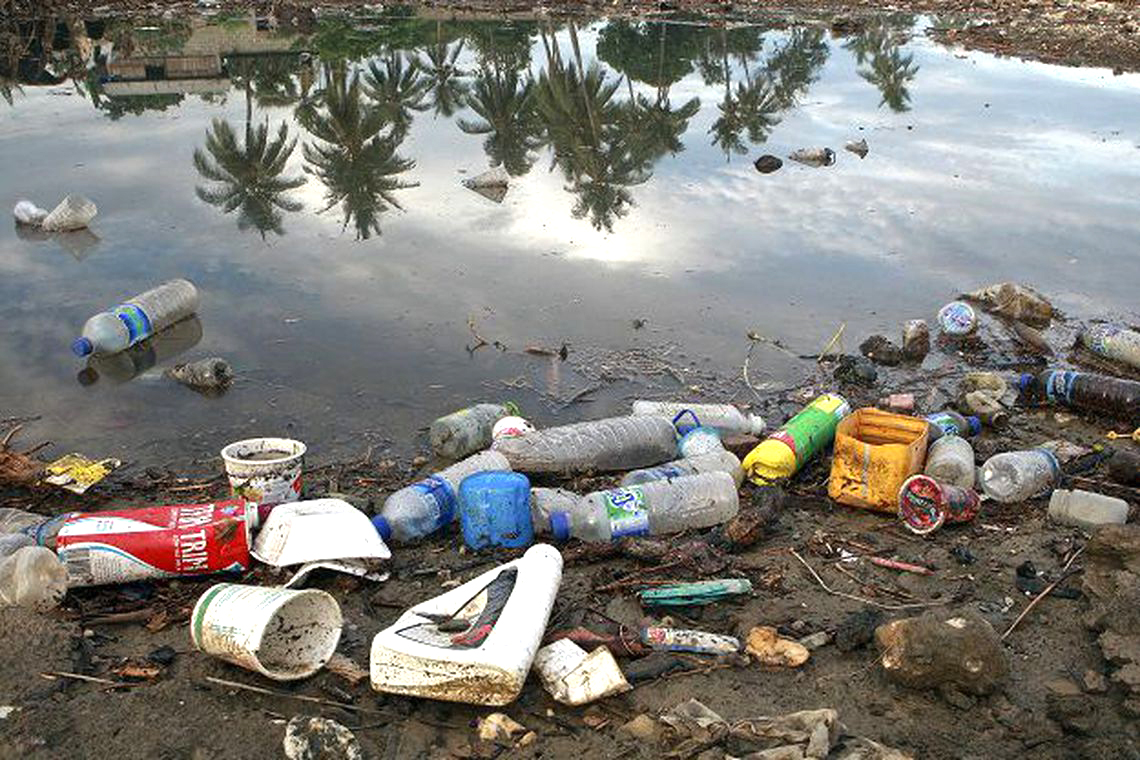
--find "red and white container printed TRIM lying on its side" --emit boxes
[56,499,257,587]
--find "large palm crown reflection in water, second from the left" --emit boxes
[298,71,415,239]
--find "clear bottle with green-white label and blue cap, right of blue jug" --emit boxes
[551,472,740,541]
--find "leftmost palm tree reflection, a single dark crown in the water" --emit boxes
[194,119,304,239]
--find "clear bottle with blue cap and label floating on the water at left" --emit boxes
[72,279,198,357]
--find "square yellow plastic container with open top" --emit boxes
[828,409,929,514]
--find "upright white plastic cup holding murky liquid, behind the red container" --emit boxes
[221,438,306,506]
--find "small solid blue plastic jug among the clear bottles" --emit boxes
[459,472,535,549]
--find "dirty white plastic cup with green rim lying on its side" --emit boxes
[190,583,343,681]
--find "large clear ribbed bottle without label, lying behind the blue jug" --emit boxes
[491,417,677,473]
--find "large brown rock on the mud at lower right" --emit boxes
[874,612,1009,695]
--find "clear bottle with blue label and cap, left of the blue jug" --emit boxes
[372,451,511,542]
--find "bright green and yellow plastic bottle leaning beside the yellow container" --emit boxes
[743,393,852,485]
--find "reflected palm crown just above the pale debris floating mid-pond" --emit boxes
[458,67,543,177]
